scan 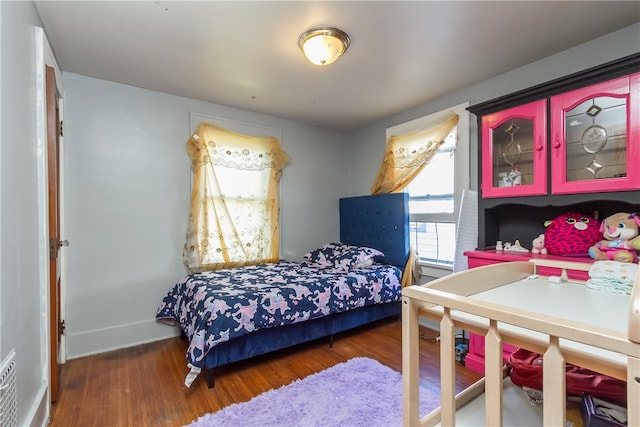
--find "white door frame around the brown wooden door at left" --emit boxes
[36,27,66,408]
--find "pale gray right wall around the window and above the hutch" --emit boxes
[350,23,640,194]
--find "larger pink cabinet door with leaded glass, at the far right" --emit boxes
[550,73,640,194]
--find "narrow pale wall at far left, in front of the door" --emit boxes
[0,1,48,426]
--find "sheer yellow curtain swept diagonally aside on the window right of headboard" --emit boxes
[371,113,458,194]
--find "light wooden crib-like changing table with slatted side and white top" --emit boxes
[402,259,640,426]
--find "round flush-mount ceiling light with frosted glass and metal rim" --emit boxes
[298,27,351,65]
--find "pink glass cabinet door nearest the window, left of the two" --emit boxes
[482,100,547,197]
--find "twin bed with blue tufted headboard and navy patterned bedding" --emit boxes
[156,193,411,387]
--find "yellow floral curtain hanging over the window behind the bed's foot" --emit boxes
[183,123,289,273]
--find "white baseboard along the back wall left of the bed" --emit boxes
[67,319,180,359]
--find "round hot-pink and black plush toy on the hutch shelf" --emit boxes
[544,212,602,256]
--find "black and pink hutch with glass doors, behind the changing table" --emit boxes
[465,57,640,373]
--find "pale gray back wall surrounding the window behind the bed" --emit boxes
[64,73,348,358]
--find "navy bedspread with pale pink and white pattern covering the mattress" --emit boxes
[156,262,402,368]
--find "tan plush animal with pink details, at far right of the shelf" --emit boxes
[589,212,640,262]
